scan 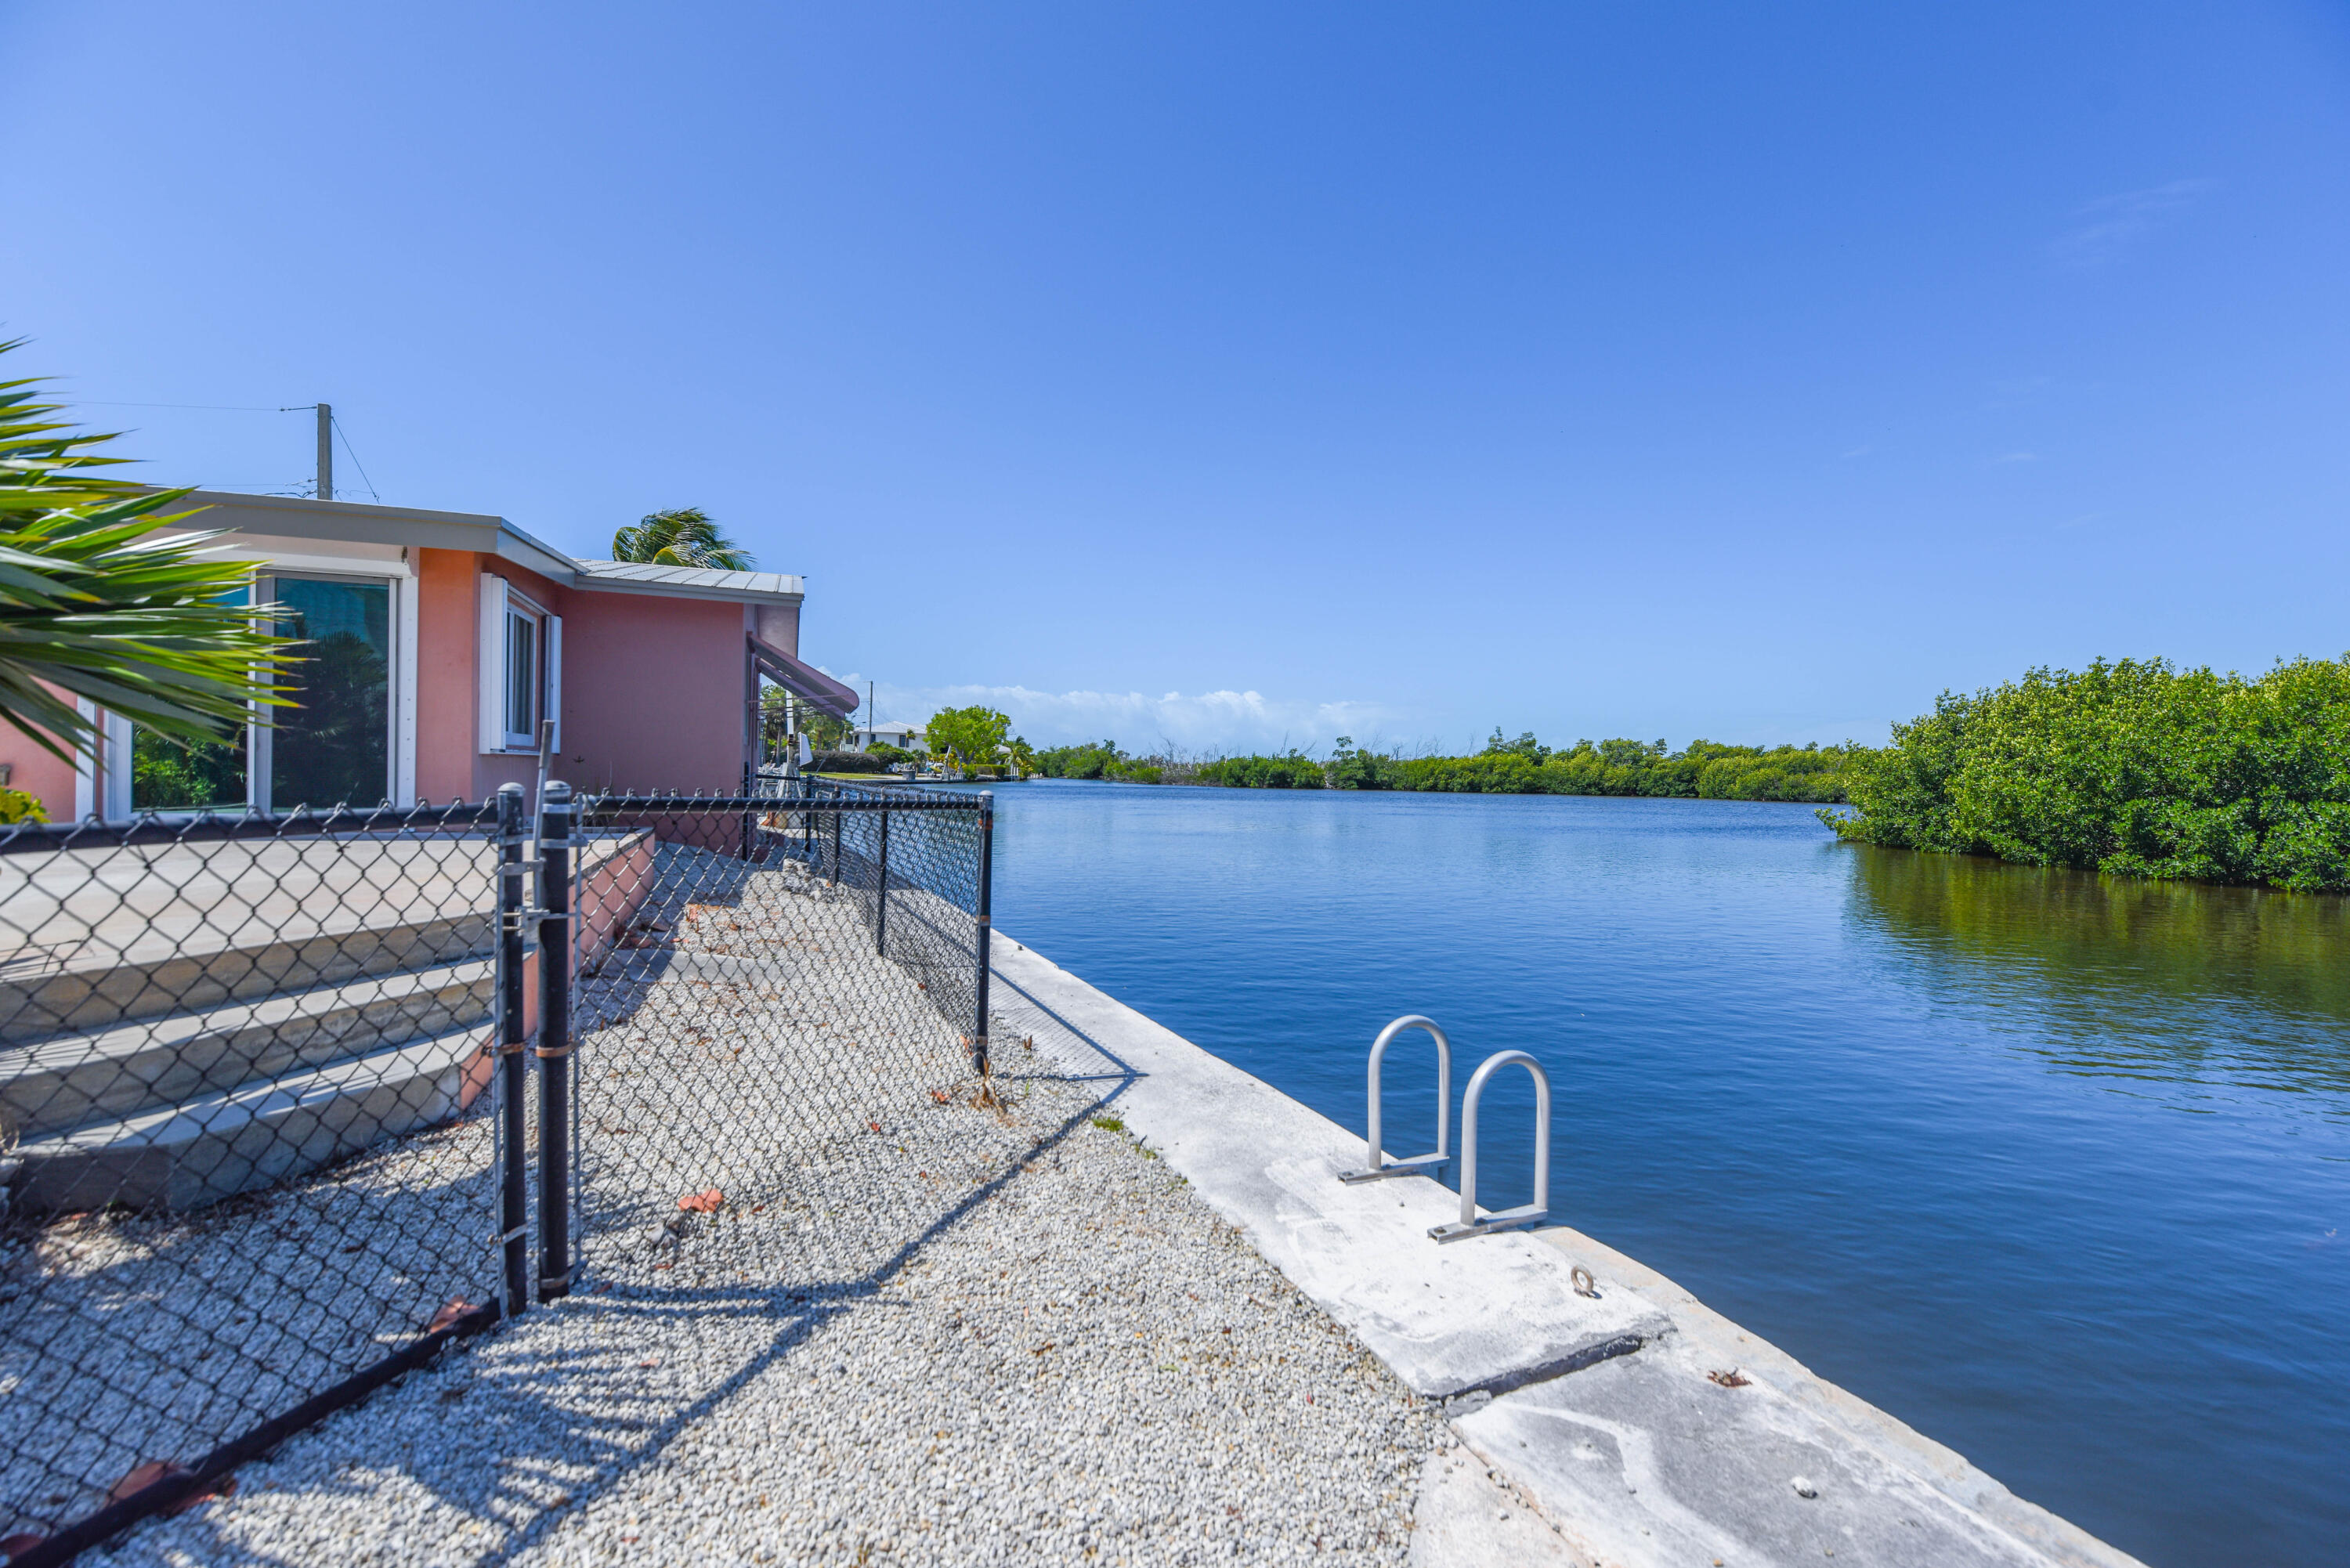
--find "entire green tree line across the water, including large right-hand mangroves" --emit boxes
[1036,653,2350,894]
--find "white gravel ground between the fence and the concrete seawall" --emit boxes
[85,846,1448,1566]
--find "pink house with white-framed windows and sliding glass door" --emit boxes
[0,491,858,821]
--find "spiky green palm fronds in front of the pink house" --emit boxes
[0,338,296,761]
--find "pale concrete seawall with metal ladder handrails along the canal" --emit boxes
[994,938,2136,1568]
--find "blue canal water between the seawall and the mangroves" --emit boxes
[996,780,2350,1568]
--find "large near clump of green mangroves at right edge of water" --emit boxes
[1821,656,2350,894]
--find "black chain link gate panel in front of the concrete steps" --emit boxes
[0,800,519,1563]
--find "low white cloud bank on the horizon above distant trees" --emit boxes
[825,670,1389,752]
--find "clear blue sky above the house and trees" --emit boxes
[0,0,2350,747]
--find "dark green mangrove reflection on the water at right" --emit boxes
[1831,849,2350,1117]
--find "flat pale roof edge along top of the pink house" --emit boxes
[151,489,806,604]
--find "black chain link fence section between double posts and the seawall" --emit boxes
[571,782,1018,1316]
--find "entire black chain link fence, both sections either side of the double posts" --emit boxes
[0,780,992,1563]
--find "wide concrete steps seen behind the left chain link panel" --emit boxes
[0,837,512,1213]
